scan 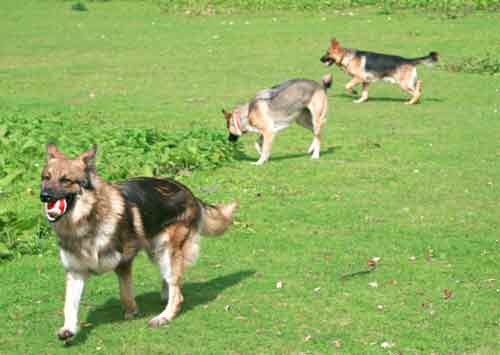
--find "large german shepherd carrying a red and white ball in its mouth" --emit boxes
[40,144,237,341]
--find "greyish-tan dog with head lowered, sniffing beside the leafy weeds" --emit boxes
[222,75,332,165]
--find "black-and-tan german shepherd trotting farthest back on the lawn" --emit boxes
[320,38,438,105]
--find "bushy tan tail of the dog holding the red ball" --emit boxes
[199,200,238,236]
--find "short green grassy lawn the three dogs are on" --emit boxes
[0,0,500,354]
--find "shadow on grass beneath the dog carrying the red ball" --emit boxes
[68,270,255,346]
